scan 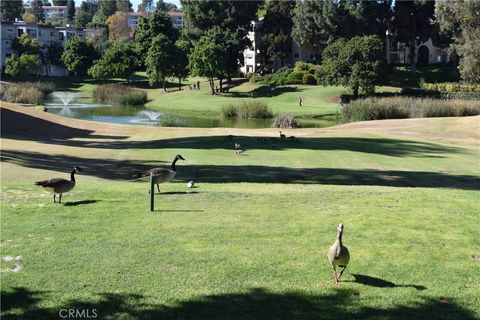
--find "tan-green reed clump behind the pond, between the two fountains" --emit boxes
[93,84,147,106]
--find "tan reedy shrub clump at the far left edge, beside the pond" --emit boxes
[0,82,55,104]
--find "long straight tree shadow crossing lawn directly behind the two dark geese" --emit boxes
[1,150,480,189]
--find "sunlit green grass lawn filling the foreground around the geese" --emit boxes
[0,104,480,319]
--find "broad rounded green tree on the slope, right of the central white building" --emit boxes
[318,36,385,98]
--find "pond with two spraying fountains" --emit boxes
[44,91,336,129]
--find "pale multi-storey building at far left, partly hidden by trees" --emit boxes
[0,21,85,76]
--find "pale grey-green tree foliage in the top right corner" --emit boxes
[435,0,480,83]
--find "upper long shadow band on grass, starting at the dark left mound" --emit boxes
[1,108,464,158]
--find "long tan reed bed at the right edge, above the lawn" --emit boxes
[342,97,480,121]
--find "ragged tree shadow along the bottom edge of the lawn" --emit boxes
[1,288,475,320]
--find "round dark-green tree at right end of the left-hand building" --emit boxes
[61,37,99,75]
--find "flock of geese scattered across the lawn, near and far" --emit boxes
[35,131,350,285]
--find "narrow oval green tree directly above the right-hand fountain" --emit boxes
[145,34,175,92]
